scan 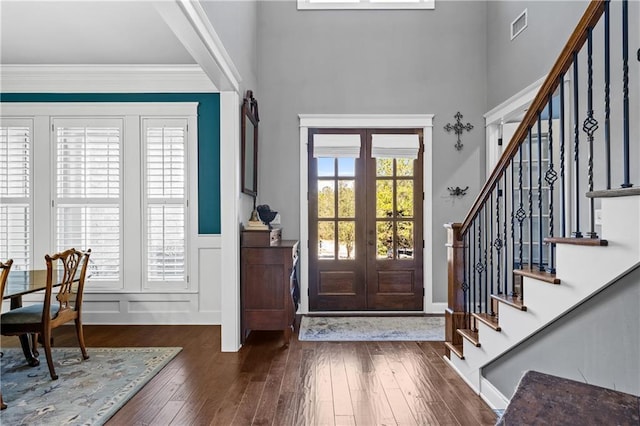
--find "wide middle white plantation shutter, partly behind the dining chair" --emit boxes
[53,118,122,282]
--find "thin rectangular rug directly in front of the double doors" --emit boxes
[298,316,444,342]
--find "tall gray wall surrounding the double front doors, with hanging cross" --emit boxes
[258,1,487,302]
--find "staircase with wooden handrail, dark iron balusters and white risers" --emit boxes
[445,1,640,409]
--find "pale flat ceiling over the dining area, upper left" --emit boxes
[0,0,195,65]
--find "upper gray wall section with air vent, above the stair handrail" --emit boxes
[488,0,588,110]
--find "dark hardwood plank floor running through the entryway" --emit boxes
[2,326,496,426]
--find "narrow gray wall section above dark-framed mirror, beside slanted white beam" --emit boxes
[200,0,258,95]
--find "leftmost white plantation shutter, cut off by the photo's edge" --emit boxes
[0,120,33,270]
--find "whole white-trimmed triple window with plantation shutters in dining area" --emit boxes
[0,102,198,292]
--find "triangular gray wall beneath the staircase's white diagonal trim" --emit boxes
[483,267,640,398]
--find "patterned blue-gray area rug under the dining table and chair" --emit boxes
[0,347,182,425]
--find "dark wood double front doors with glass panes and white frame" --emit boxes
[300,115,437,313]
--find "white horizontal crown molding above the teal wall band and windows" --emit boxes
[0,65,218,93]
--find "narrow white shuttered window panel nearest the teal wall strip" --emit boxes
[143,119,187,284]
